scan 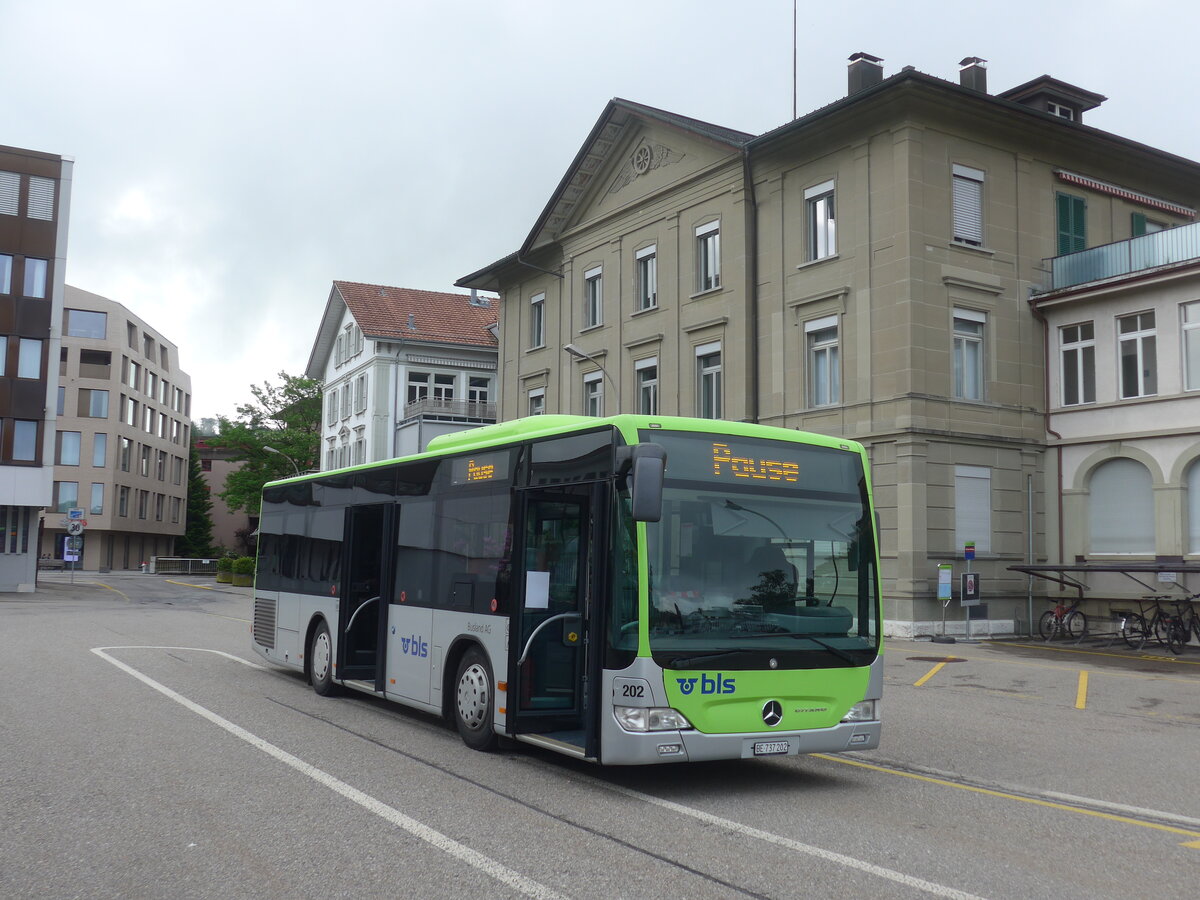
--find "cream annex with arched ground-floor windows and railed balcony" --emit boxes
[1032,224,1200,596]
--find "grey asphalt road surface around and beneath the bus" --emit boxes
[0,574,1200,900]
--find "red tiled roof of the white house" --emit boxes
[334,281,499,347]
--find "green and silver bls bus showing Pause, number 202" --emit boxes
[252,415,883,764]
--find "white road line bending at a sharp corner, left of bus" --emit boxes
[91,647,566,900]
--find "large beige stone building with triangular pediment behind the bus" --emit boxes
[457,54,1200,635]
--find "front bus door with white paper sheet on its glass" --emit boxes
[508,486,593,752]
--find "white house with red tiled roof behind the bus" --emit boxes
[305,281,497,470]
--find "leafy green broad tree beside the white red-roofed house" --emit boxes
[208,372,322,516]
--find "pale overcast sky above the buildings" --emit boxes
[0,0,1200,419]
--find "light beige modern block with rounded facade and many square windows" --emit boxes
[41,286,192,571]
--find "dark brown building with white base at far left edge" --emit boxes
[0,146,73,592]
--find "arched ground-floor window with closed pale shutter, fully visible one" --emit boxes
[1088,458,1154,553]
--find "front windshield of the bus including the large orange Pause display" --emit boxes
[643,432,880,668]
